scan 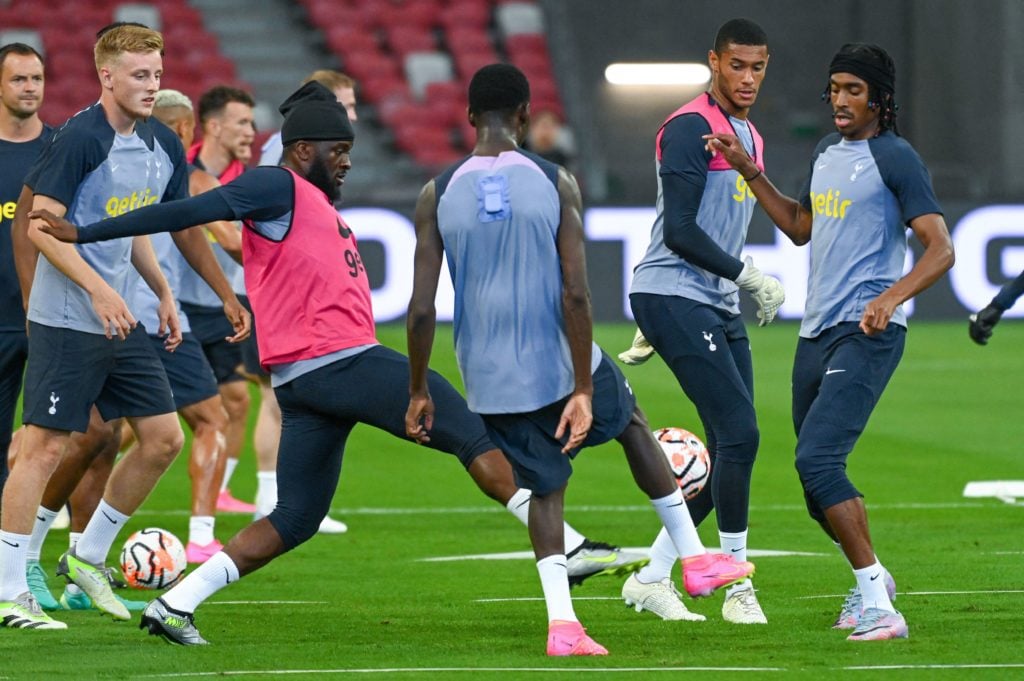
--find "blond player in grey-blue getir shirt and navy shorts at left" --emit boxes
[0,25,249,629]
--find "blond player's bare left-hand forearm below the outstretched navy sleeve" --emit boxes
[28,195,137,340]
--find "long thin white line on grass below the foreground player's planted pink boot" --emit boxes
[139,667,786,679]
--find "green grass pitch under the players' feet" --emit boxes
[6,321,1024,680]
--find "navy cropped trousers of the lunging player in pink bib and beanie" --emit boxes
[268,345,495,549]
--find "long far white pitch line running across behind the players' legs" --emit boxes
[135,502,1001,516]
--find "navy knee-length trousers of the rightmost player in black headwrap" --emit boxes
[793,322,906,515]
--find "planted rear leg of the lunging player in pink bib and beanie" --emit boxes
[139,382,354,645]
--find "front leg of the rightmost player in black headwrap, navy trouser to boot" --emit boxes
[797,323,907,640]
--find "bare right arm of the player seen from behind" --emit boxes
[555,168,594,453]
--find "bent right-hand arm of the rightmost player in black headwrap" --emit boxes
[860,213,954,336]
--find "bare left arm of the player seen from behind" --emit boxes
[406,180,444,443]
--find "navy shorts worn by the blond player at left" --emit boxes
[24,322,175,432]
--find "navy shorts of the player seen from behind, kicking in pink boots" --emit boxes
[483,353,636,496]
